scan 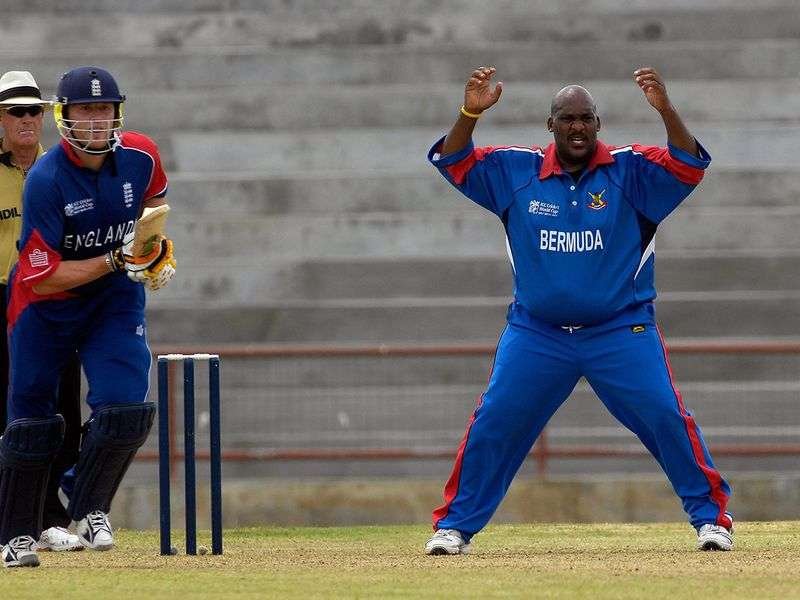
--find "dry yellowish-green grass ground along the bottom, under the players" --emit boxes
[0,522,800,600]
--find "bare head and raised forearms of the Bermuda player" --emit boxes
[440,67,698,173]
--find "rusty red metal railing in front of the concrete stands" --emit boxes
[138,338,800,475]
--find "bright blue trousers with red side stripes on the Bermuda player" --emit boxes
[433,304,730,540]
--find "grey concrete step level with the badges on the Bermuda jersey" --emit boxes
[169,166,800,217]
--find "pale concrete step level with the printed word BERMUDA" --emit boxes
[158,204,800,268]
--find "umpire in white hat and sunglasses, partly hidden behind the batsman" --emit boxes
[0,71,83,551]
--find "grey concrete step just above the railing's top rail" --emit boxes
[148,292,800,343]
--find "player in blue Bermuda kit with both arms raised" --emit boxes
[425,67,733,555]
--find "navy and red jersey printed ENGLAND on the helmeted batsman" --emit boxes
[8,131,167,328]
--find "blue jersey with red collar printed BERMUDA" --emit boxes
[428,138,711,326]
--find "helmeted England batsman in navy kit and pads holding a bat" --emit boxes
[0,66,175,567]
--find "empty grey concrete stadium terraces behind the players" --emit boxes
[7,0,800,476]
